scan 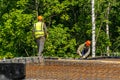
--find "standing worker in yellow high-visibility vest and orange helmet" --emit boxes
[33,16,48,62]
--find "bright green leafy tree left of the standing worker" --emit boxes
[0,0,32,56]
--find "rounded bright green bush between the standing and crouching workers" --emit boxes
[45,24,76,57]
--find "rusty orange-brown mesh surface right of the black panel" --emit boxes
[26,59,120,80]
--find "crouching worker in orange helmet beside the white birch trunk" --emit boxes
[77,40,91,59]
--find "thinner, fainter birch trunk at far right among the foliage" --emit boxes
[106,3,110,56]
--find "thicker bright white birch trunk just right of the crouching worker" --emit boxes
[91,0,96,57]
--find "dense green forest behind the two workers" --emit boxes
[0,0,120,58]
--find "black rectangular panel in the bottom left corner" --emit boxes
[0,63,25,80]
